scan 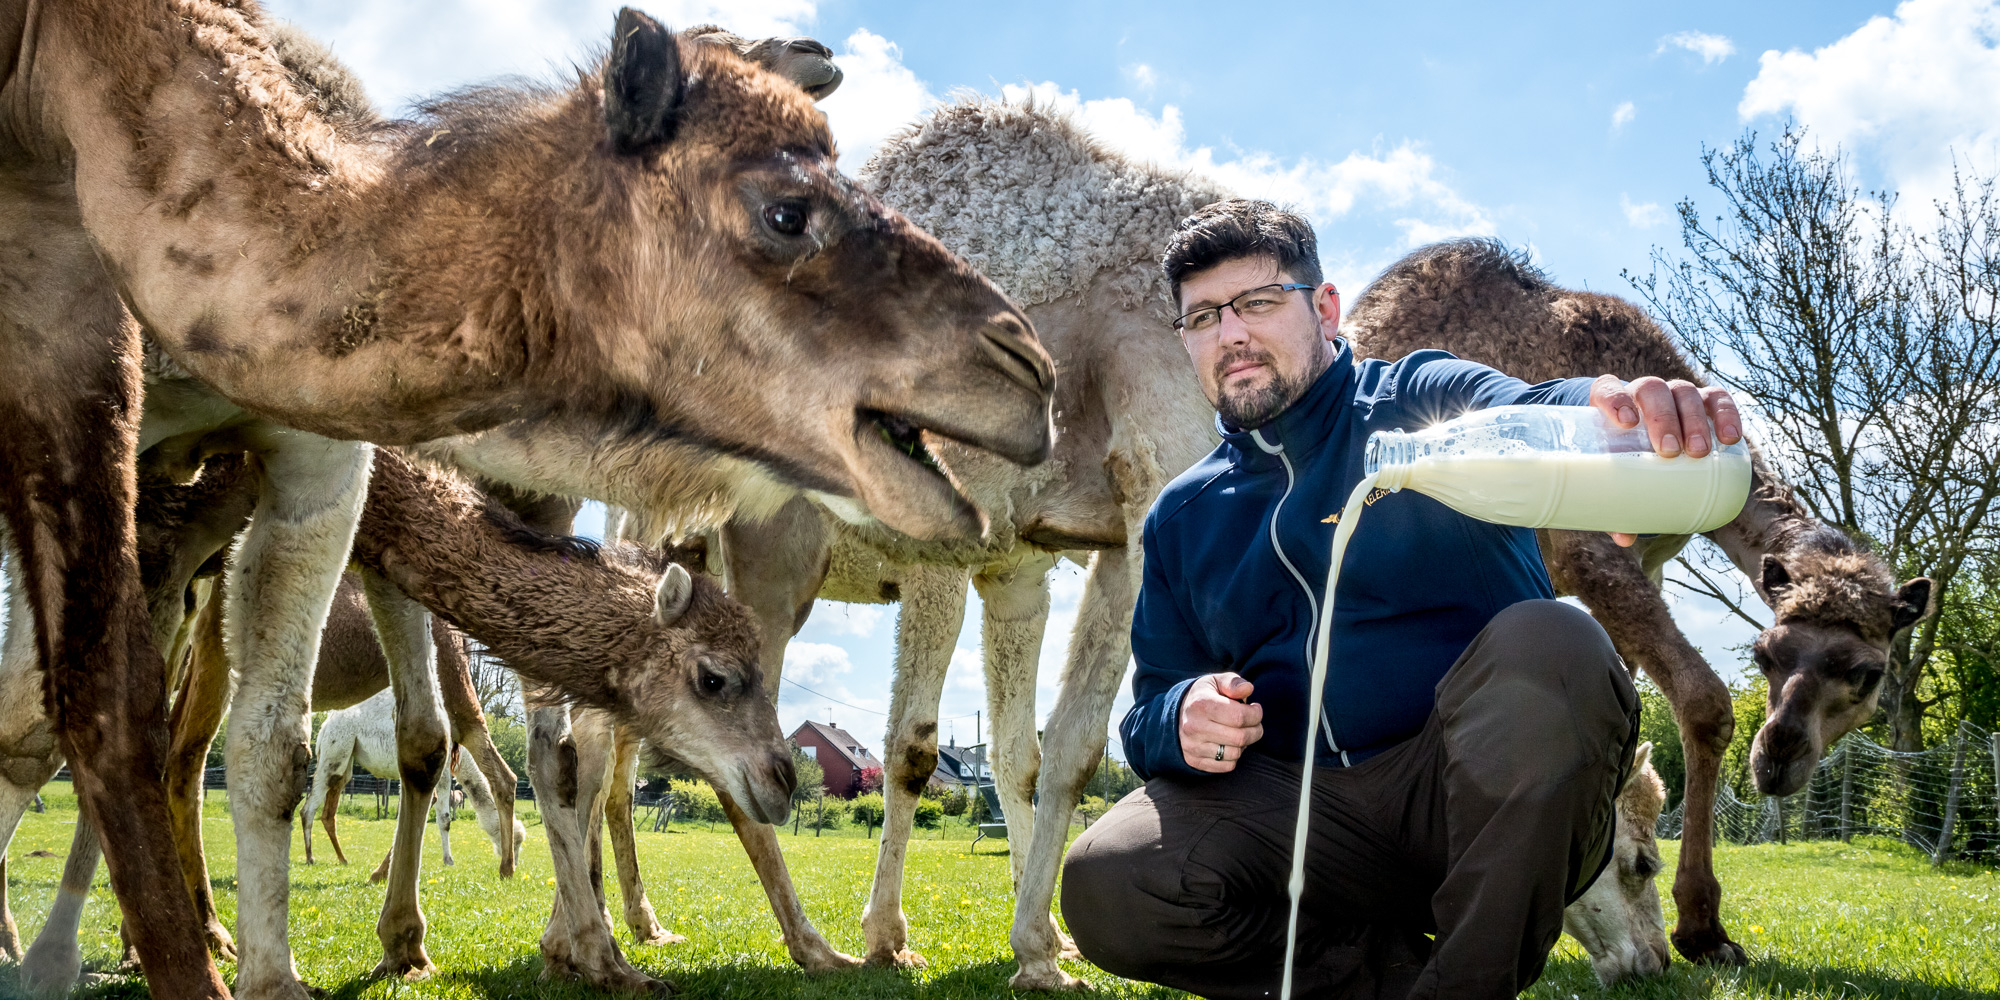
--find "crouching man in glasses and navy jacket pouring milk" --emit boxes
[1062,200,1742,998]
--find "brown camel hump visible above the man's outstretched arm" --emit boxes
[1342,238,1702,382]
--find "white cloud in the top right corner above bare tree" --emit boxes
[1736,0,2000,206]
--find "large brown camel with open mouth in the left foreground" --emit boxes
[0,0,1052,1000]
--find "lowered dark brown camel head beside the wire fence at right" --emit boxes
[1750,528,1932,796]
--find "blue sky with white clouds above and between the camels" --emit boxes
[0,0,1968,750]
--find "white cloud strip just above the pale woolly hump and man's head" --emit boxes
[1000,82,1496,256]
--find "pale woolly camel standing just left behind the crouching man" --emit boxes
[588,100,1224,988]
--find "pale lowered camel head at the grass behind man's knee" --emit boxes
[1562,744,1668,986]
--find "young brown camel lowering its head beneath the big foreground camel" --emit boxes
[354,450,794,990]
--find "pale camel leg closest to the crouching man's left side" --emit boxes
[1008,540,1140,990]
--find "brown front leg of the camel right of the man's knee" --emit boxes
[1542,532,1746,966]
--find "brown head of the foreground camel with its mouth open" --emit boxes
[428,8,1054,538]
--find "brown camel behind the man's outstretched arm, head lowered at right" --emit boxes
[1344,240,1932,964]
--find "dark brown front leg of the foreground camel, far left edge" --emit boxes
[0,184,228,1000]
